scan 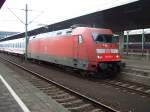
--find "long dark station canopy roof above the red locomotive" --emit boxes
[0,0,150,40]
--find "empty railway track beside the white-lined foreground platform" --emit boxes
[0,57,119,112]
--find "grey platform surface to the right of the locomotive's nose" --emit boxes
[120,58,150,86]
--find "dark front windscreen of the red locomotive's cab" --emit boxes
[92,33,116,43]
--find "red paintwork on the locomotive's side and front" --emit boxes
[28,27,121,70]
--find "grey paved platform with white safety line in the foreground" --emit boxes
[0,62,68,112]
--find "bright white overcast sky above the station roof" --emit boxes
[0,0,137,32]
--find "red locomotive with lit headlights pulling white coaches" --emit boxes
[0,27,121,76]
